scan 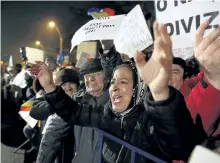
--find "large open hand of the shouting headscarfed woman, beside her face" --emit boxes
[134,22,173,100]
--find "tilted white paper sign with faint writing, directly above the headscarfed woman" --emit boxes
[114,5,153,57]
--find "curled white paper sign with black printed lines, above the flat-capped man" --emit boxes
[70,15,125,51]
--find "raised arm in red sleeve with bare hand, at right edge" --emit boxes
[185,21,220,136]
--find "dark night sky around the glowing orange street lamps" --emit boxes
[1,1,153,61]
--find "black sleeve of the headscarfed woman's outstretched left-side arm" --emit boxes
[45,87,104,128]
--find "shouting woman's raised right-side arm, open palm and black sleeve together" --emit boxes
[135,23,196,160]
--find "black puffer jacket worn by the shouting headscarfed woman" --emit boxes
[45,87,197,163]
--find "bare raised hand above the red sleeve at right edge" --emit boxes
[194,20,220,90]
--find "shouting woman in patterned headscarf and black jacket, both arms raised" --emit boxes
[30,23,199,163]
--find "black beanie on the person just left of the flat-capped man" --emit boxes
[56,69,79,87]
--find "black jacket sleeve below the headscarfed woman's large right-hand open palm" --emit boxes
[145,87,197,161]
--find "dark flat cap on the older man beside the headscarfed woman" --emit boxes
[79,58,103,75]
